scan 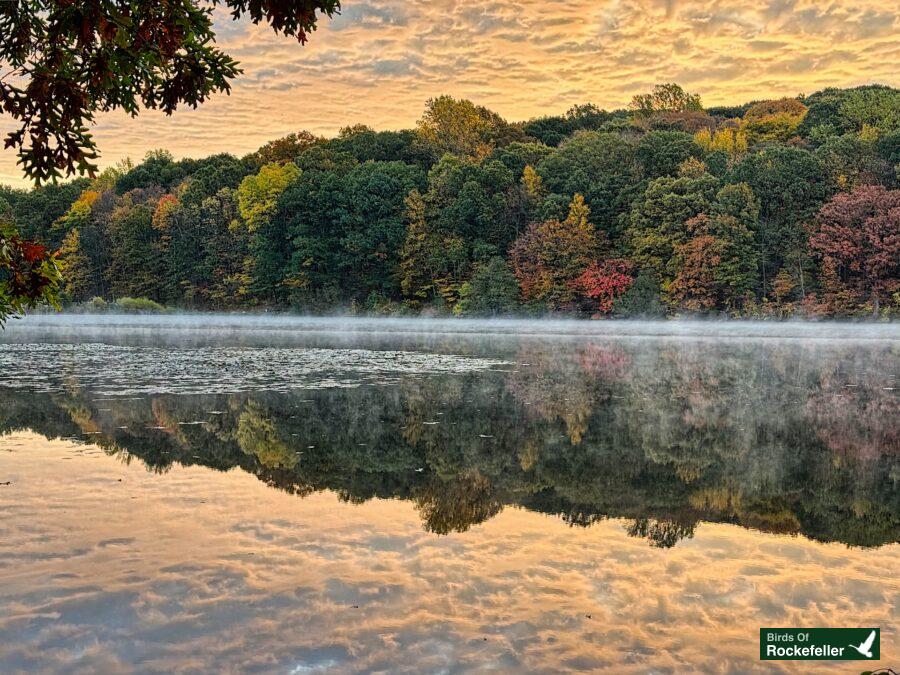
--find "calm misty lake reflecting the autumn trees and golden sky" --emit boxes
[0,315,900,673]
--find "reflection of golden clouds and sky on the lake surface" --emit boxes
[0,433,900,674]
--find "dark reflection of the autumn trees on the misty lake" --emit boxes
[0,338,900,548]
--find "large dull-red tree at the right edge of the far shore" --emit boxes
[809,185,900,311]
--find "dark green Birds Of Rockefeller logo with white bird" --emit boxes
[759,628,881,661]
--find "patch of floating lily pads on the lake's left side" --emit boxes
[0,343,509,397]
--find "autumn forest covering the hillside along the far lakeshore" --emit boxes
[0,84,900,318]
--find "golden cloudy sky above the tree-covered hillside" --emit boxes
[0,0,900,186]
